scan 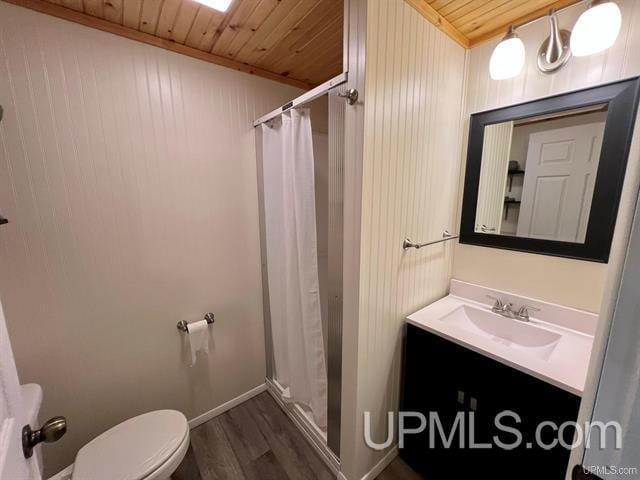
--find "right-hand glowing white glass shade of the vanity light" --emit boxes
[571,2,622,57]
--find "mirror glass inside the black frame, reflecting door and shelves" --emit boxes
[475,105,607,243]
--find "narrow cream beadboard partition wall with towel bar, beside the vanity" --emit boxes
[357,0,465,478]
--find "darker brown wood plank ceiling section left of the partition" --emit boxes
[5,0,344,89]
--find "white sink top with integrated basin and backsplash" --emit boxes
[407,279,598,395]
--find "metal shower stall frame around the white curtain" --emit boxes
[254,73,347,473]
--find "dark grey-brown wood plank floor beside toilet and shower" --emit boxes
[171,393,423,480]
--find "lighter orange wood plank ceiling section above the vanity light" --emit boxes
[406,0,581,48]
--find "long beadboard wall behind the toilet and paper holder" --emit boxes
[0,2,300,473]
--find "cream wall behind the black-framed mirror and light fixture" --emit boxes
[453,0,640,312]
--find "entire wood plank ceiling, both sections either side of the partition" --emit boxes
[5,0,580,89]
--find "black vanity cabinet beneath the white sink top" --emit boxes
[400,325,580,480]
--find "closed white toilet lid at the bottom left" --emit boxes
[71,410,189,480]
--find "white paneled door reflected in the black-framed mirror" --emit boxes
[517,123,604,243]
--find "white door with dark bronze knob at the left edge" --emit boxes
[0,304,41,480]
